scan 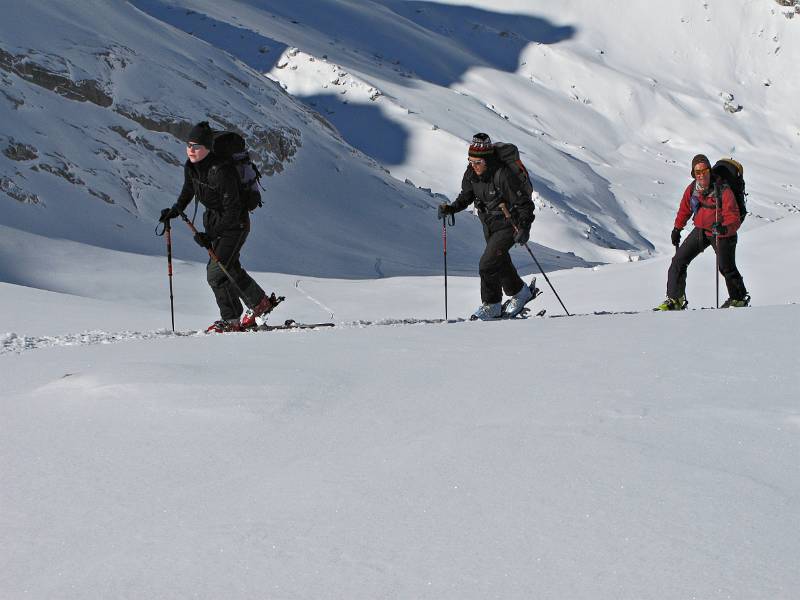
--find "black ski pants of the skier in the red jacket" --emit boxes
[667,227,747,300]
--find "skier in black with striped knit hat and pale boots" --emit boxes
[439,133,535,320]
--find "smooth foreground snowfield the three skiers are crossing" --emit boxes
[0,223,800,600]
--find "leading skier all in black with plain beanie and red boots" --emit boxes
[159,121,274,333]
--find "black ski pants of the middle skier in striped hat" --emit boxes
[478,225,525,304]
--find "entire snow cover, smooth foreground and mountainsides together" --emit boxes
[0,0,800,600]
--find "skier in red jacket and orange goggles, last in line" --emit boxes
[656,154,750,310]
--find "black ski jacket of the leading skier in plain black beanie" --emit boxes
[174,153,249,238]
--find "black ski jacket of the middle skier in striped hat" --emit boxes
[452,160,534,232]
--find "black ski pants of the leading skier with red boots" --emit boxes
[206,223,264,321]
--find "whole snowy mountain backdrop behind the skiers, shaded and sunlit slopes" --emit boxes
[0,0,800,277]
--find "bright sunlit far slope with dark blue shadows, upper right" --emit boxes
[136,0,800,262]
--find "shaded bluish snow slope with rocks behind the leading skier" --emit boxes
[0,2,494,277]
